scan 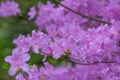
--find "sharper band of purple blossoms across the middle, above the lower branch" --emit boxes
[5,23,120,80]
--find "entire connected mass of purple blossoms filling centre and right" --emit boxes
[5,0,120,80]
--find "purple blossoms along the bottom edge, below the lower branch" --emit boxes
[16,62,120,80]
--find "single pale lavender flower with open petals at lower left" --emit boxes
[5,52,30,76]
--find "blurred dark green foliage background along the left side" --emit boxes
[0,0,39,80]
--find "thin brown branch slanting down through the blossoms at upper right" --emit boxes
[55,0,111,25]
